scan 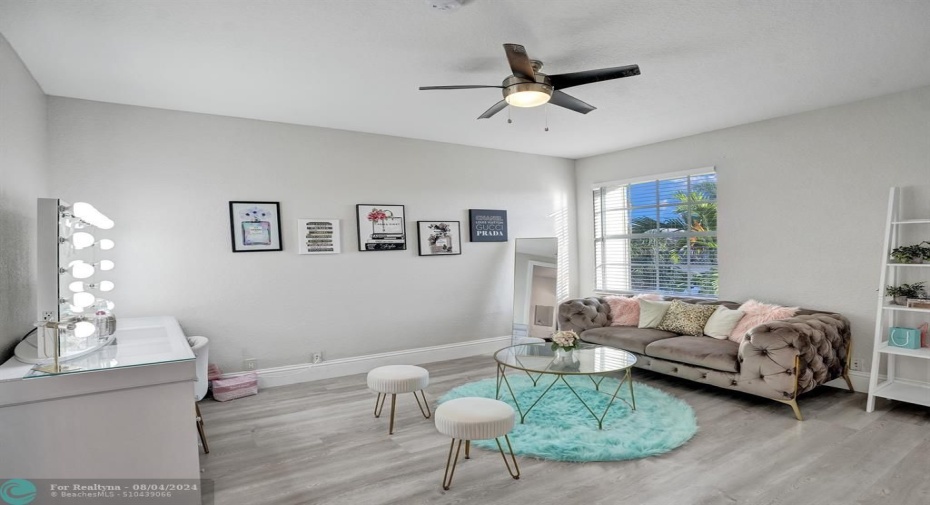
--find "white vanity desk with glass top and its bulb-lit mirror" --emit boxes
[0,199,200,480]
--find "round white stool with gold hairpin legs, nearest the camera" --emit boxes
[436,397,520,489]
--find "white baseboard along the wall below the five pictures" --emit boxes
[226,335,511,388]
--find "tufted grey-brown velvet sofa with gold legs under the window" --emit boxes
[559,297,853,420]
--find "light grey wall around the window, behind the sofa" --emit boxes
[576,87,930,380]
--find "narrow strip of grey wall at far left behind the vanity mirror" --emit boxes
[0,35,48,362]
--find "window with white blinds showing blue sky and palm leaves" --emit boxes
[594,170,717,298]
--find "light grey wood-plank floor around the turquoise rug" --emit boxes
[200,356,930,505]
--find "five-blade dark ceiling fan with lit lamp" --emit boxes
[420,44,639,119]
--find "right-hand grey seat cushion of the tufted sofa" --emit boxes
[640,332,739,372]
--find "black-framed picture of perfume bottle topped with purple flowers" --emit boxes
[229,202,282,252]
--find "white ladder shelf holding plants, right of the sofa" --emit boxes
[866,186,930,412]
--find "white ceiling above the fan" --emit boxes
[0,0,930,158]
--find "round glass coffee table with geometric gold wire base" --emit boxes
[494,343,636,429]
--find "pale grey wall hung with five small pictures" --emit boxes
[49,97,575,371]
